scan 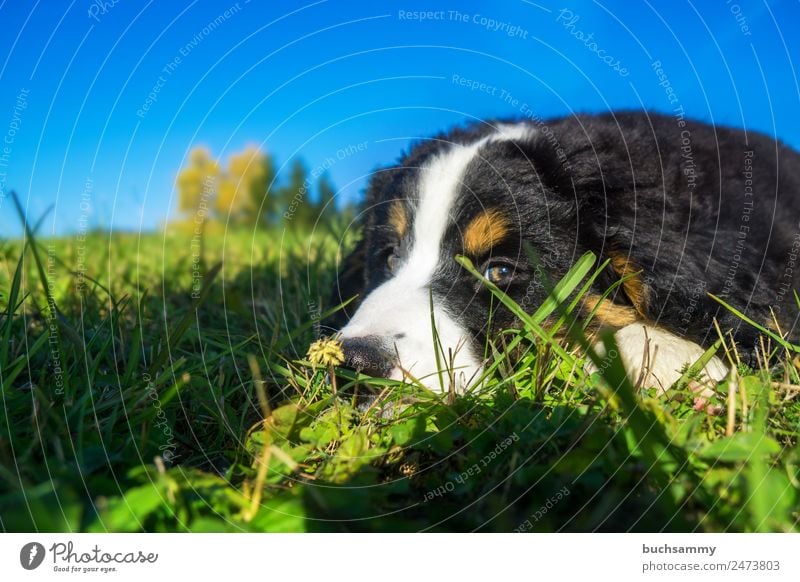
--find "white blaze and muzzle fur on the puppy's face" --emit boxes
[341,125,535,390]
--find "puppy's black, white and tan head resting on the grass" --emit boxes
[332,122,579,390]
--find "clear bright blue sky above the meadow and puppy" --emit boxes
[0,0,800,237]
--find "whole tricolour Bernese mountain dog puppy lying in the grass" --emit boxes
[326,112,800,391]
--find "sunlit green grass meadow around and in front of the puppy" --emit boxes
[0,214,800,531]
